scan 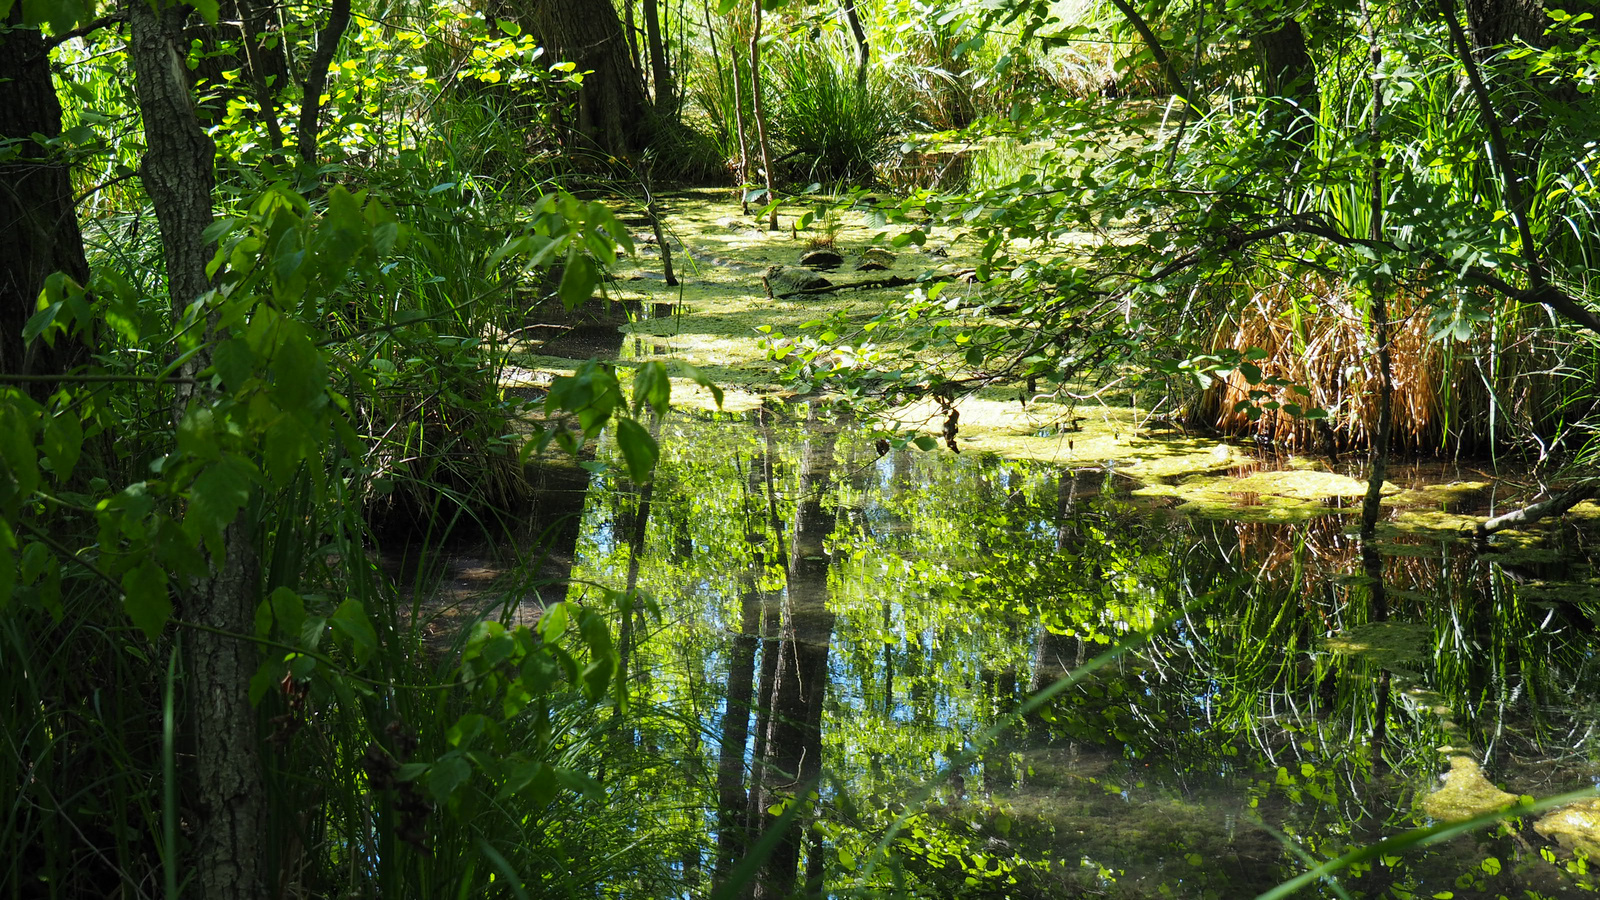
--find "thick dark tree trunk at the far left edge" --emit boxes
[0,3,90,375]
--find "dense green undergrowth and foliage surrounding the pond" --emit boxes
[0,0,1600,897]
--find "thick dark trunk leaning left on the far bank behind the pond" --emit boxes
[520,0,654,157]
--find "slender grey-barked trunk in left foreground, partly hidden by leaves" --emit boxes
[126,0,266,900]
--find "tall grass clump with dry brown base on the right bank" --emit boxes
[1192,19,1600,458]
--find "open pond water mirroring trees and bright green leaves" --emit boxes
[432,410,1600,898]
